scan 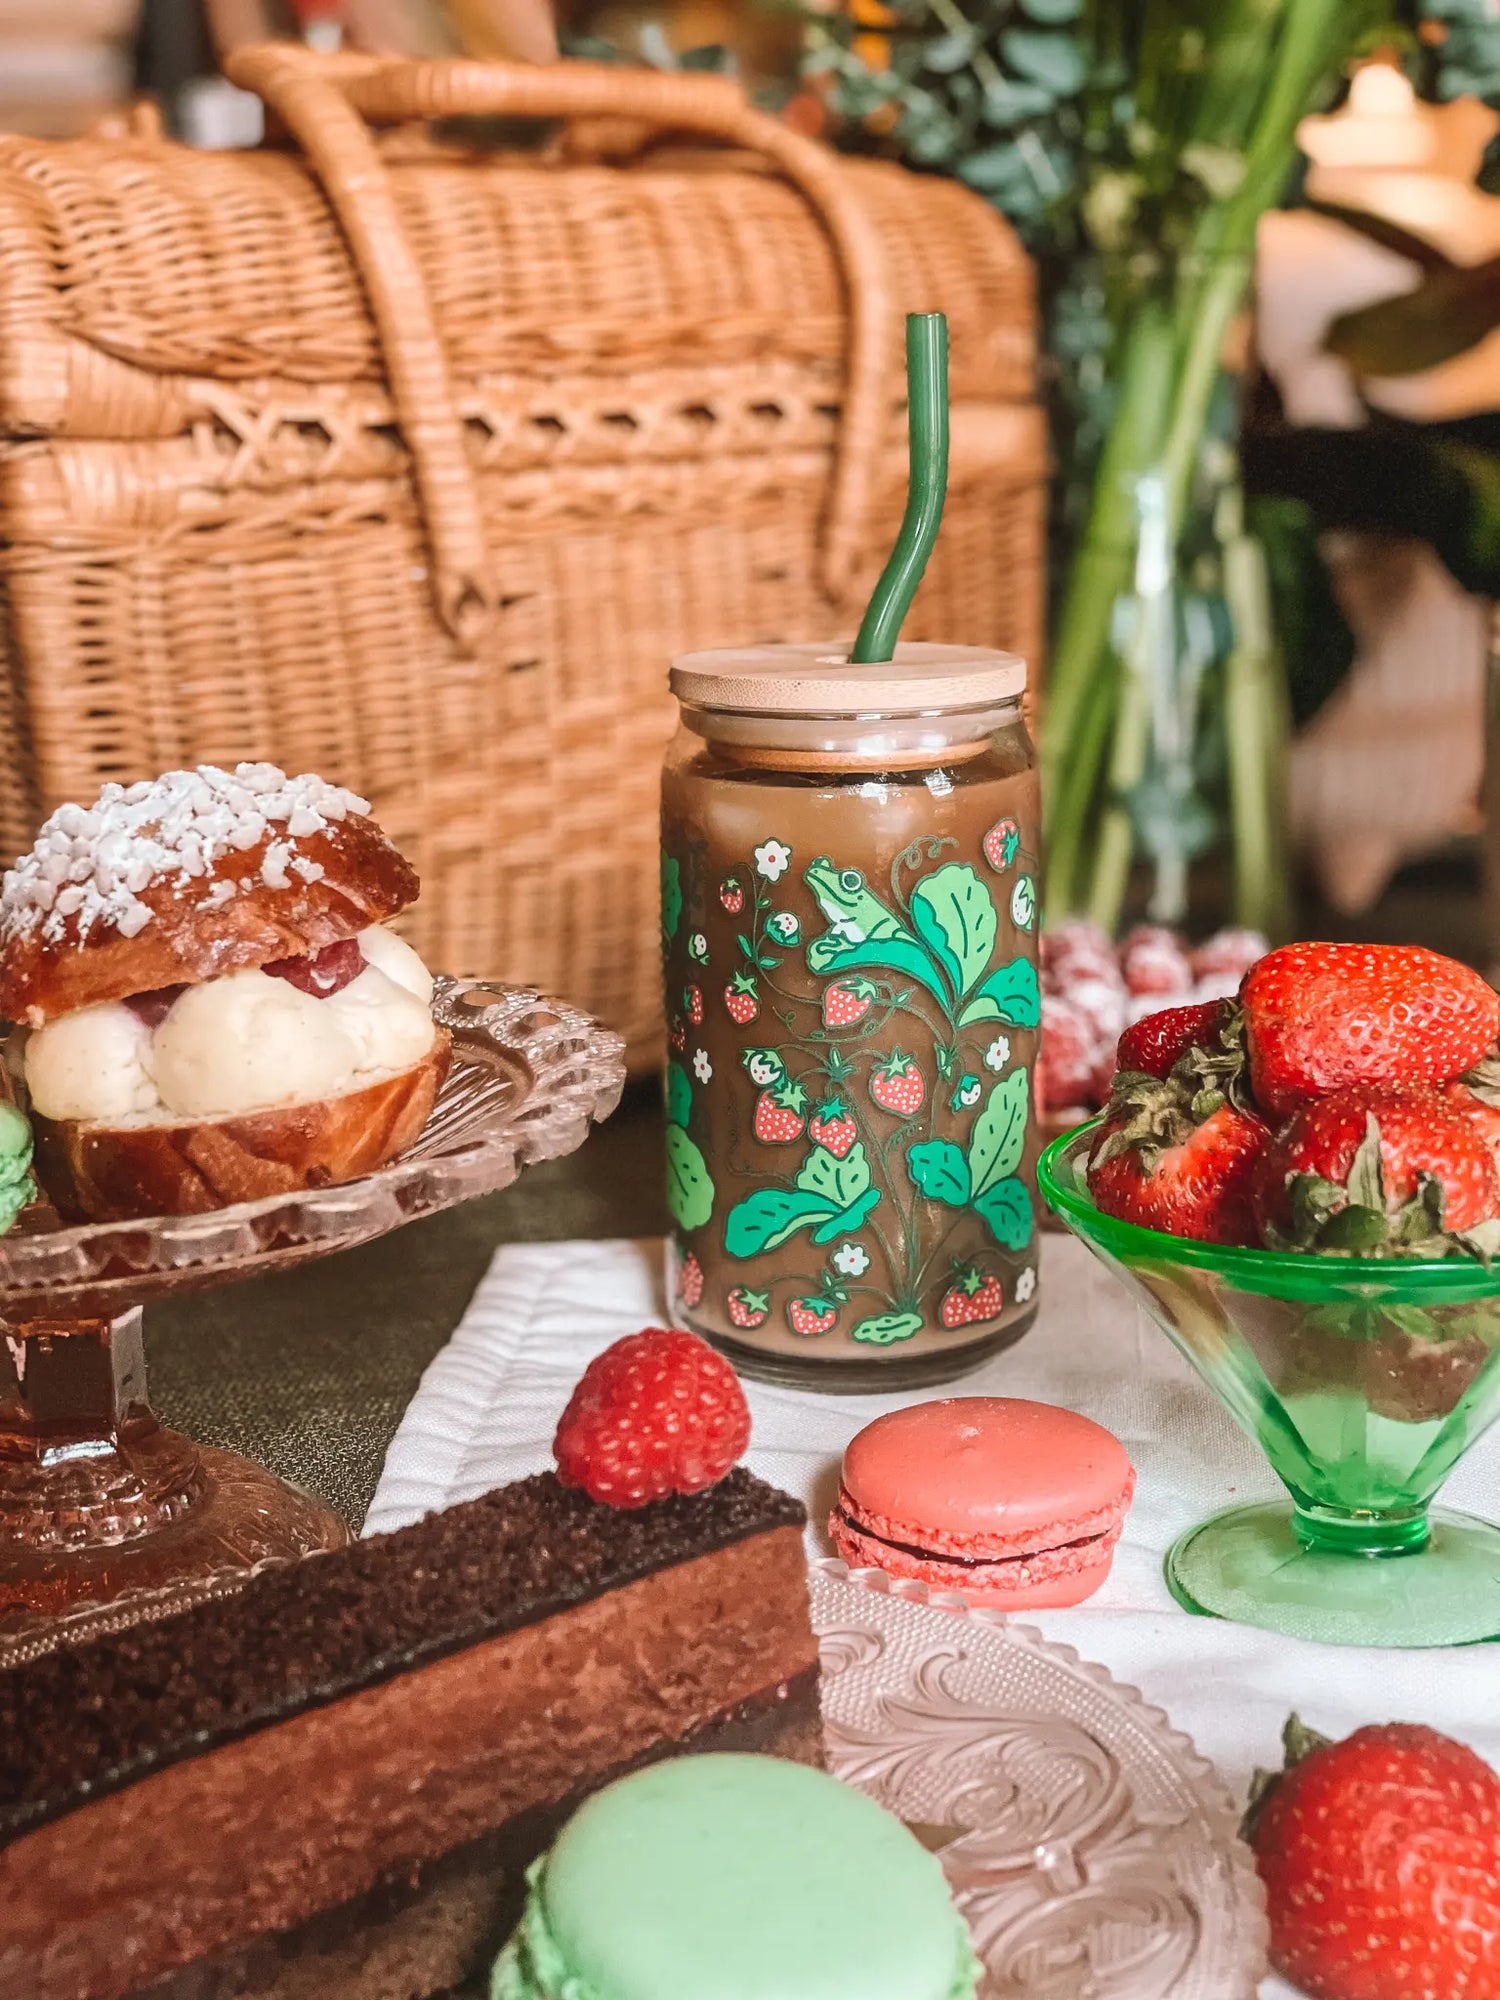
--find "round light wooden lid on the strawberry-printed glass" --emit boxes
[672,644,1026,716]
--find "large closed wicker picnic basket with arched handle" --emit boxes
[0,44,1044,1064]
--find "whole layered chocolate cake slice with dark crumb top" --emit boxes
[0,1470,822,2000]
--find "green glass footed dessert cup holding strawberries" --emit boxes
[1038,1120,1500,1646]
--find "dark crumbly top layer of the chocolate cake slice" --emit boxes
[0,1468,806,1846]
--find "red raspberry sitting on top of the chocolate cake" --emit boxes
[552,1326,750,1506]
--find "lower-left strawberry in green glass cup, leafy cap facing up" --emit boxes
[1088,1076,1270,1244]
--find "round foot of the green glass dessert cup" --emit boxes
[1166,1500,1500,1646]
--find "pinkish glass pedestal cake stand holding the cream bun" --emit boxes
[0,978,624,1666]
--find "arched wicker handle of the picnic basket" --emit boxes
[226,42,894,646]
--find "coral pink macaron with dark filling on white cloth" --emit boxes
[828,1396,1136,1610]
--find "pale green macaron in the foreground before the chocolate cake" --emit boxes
[490,1756,980,2000]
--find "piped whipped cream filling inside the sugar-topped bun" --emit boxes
[24,928,434,1124]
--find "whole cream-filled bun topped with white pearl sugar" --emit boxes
[0,764,450,1218]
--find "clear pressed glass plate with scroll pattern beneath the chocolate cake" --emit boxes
[812,1560,1266,2000]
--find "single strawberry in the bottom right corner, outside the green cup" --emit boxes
[1246,1716,1500,2000]
